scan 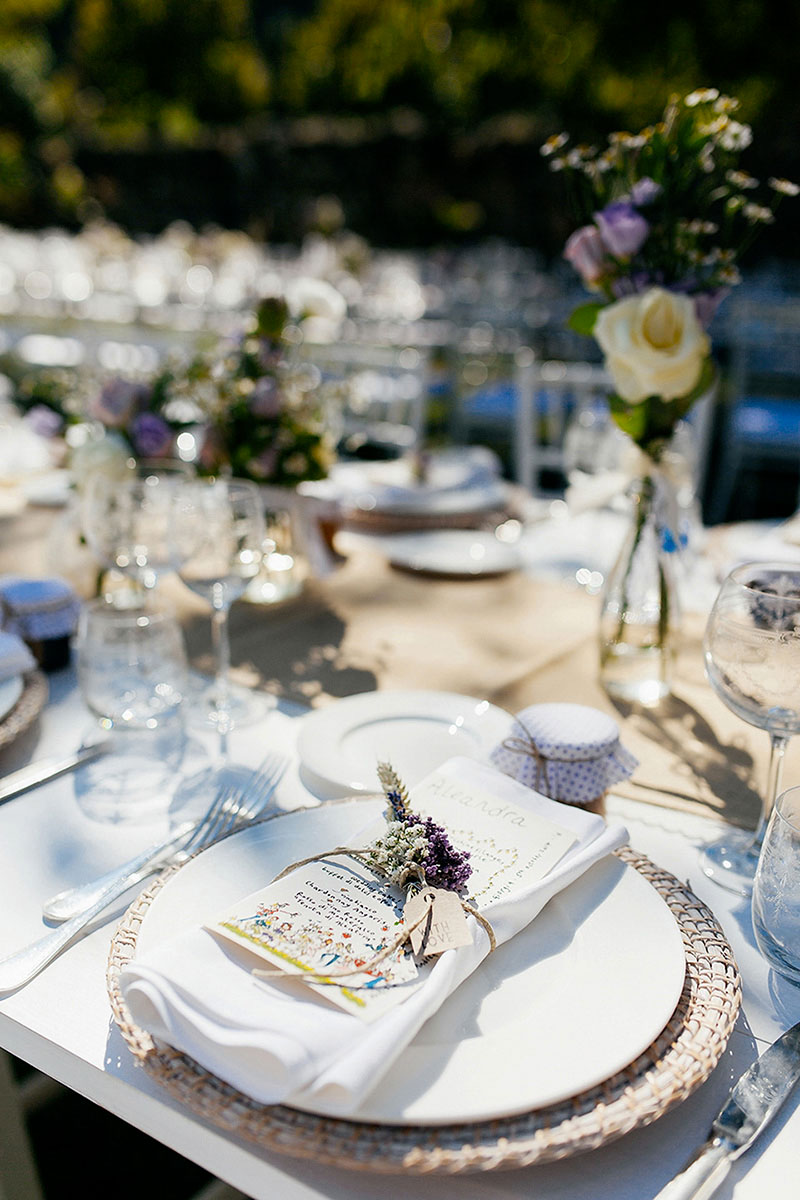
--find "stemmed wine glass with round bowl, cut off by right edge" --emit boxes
[703,563,800,895]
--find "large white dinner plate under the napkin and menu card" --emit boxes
[137,798,686,1124]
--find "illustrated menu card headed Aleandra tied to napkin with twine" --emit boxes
[206,770,576,1021]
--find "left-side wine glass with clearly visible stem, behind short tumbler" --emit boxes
[174,479,266,734]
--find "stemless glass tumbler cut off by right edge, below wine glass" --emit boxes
[752,787,800,984]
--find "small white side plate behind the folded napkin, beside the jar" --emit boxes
[297,691,513,796]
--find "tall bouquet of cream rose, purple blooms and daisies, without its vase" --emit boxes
[542,88,800,461]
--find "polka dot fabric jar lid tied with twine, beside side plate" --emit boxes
[491,704,638,804]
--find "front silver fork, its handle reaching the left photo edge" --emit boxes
[0,756,287,995]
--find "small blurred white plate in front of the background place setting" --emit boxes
[374,529,521,578]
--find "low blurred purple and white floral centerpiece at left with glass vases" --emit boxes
[13,290,345,602]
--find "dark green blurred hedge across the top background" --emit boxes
[0,0,800,256]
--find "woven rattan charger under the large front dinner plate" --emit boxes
[108,818,741,1175]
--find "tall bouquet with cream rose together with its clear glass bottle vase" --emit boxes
[542,88,800,702]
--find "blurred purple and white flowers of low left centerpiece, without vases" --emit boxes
[10,289,335,487]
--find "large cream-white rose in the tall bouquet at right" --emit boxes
[594,288,711,402]
